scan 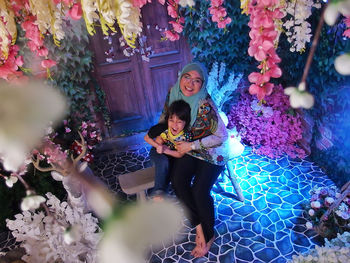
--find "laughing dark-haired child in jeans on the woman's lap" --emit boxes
[145,100,193,199]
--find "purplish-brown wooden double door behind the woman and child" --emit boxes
[91,1,191,136]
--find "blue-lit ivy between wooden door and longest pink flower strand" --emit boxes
[180,1,254,75]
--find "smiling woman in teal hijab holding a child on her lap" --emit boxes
[162,63,228,257]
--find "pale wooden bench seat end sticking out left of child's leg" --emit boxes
[118,166,155,201]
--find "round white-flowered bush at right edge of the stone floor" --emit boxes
[305,186,350,238]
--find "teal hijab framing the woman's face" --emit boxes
[169,62,208,126]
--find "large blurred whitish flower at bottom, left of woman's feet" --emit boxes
[99,201,182,263]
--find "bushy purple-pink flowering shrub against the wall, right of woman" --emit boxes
[228,86,305,158]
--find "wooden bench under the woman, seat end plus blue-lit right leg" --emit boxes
[118,162,244,202]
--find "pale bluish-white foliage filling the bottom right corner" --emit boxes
[288,232,350,263]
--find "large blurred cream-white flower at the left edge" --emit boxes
[0,82,66,171]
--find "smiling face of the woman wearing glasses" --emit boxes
[180,70,203,97]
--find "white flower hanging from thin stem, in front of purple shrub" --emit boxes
[284,82,315,109]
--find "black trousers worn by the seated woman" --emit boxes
[170,154,224,242]
